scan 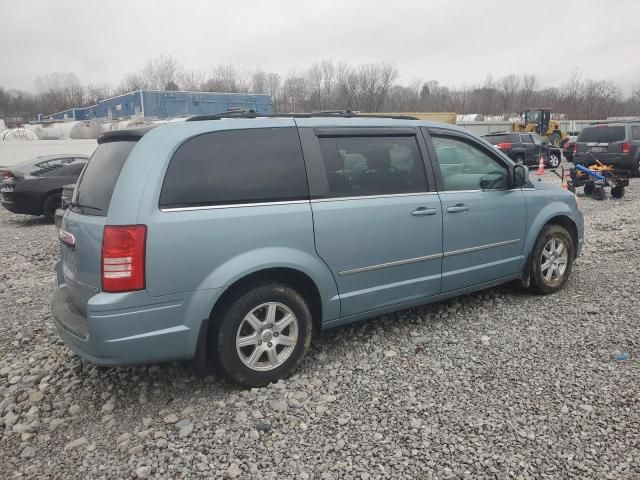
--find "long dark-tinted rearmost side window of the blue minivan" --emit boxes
[160,128,309,207]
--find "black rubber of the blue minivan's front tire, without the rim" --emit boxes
[531,225,575,295]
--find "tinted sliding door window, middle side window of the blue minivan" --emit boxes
[318,136,427,197]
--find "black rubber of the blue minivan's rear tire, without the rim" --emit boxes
[209,282,313,387]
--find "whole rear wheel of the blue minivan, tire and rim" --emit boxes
[209,283,312,387]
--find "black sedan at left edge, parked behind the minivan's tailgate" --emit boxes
[0,155,89,220]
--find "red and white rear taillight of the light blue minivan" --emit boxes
[102,225,147,292]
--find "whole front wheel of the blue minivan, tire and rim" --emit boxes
[531,225,575,294]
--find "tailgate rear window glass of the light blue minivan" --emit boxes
[73,141,136,216]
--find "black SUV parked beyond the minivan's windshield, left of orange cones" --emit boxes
[484,132,562,168]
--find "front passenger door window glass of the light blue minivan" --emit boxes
[433,136,508,191]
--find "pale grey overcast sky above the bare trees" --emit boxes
[0,0,640,94]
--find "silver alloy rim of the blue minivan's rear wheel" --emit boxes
[236,302,299,372]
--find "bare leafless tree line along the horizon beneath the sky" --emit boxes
[0,56,640,123]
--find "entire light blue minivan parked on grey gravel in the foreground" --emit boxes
[52,112,583,386]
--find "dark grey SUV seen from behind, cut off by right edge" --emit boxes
[573,119,640,176]
